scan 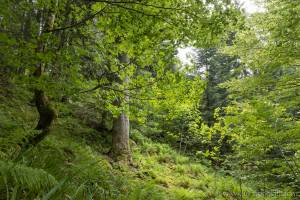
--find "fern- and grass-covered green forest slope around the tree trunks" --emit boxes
[0,85,282,200]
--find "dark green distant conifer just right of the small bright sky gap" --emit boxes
[196,48,239,126]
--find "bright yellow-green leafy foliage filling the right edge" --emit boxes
[220,0,300,189]
